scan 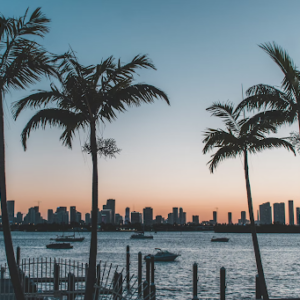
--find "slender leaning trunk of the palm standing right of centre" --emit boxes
[244,150,269,300]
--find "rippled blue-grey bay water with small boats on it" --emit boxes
[0,232,300,300]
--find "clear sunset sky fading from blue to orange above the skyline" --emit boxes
[0,0,300,222]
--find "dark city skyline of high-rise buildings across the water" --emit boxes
[3,199,300,226]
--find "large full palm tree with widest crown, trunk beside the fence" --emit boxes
[13,52,170,300]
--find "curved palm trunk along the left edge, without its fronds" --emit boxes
[0,90,25,300]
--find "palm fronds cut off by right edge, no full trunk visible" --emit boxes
[237,42,300,133]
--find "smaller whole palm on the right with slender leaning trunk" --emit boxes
[203,103,295,300]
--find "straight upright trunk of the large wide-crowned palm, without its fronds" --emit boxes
[84,121,98,300]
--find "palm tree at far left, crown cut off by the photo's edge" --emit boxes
[0,8,52,300]
